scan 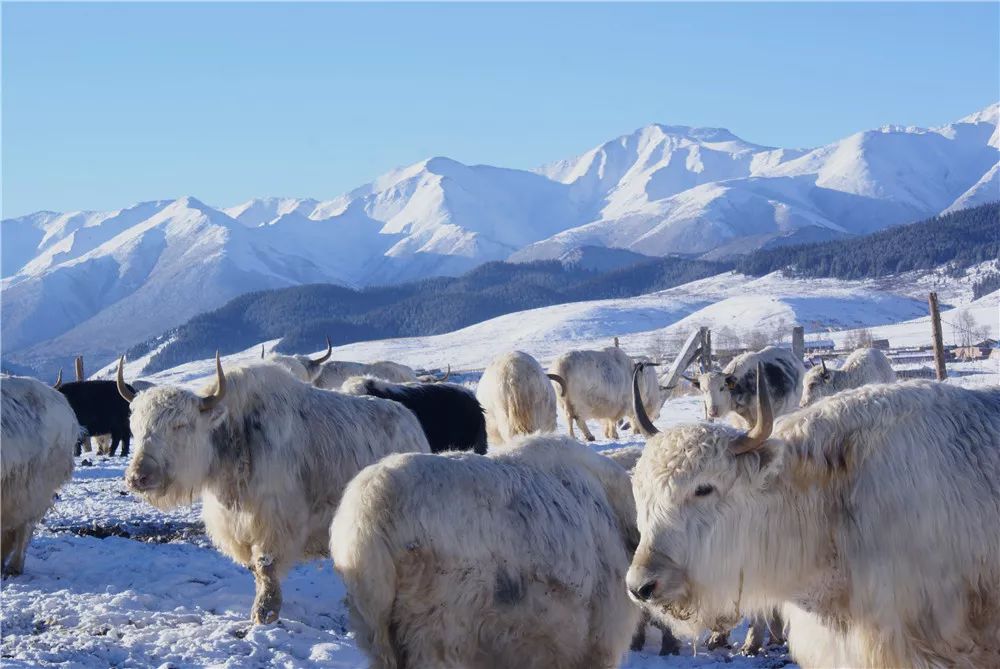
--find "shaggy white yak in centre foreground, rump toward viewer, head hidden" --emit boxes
[330,436,638,669]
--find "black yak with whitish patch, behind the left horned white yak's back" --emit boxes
[342,376,486,455]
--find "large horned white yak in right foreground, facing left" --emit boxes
[627,366,1000,668]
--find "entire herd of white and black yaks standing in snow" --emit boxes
[0,342,1000,669]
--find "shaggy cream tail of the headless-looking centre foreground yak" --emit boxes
[330,468,405,669]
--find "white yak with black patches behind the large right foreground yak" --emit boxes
[688,346,806,427]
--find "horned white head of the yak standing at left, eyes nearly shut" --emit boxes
[118,353,226,509]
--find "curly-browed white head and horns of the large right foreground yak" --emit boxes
[626,362,778,634]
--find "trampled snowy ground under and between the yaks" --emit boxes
[0,397,789,669]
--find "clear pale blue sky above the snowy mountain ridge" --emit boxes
[2,3,1000,216]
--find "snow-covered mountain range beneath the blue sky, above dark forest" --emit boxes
[0,104,1000,370]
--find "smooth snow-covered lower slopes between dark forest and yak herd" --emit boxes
[105,264,1000,384]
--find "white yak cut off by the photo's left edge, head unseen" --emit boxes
[0,375,81,576]
